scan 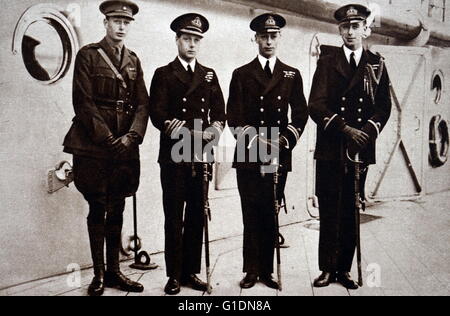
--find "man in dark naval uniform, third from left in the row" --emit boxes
[228,13,308,289]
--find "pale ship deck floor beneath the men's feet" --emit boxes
[0,192,450,297]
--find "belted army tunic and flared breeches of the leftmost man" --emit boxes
[64,38,148,204]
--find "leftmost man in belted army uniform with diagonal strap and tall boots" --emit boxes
[64,1,148,296]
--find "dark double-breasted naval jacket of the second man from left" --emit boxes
[150,57,226,164]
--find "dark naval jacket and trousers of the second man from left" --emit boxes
[150,57,226,280]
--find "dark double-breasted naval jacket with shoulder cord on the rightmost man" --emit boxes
[309,47,392,164]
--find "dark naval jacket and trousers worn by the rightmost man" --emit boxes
[309,47,392,273]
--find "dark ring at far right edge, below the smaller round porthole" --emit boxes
[430,115,450,168]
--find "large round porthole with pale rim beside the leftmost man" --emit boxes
[13,4,79,84]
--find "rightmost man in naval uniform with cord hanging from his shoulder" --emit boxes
[310,5,392,289]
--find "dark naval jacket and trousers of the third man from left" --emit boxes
[227,58,308,275]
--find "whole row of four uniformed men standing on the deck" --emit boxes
[64,0,391,296]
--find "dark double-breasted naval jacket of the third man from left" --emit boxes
[227,58,308,171]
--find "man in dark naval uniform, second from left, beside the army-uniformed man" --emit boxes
[150,13,226,295]
